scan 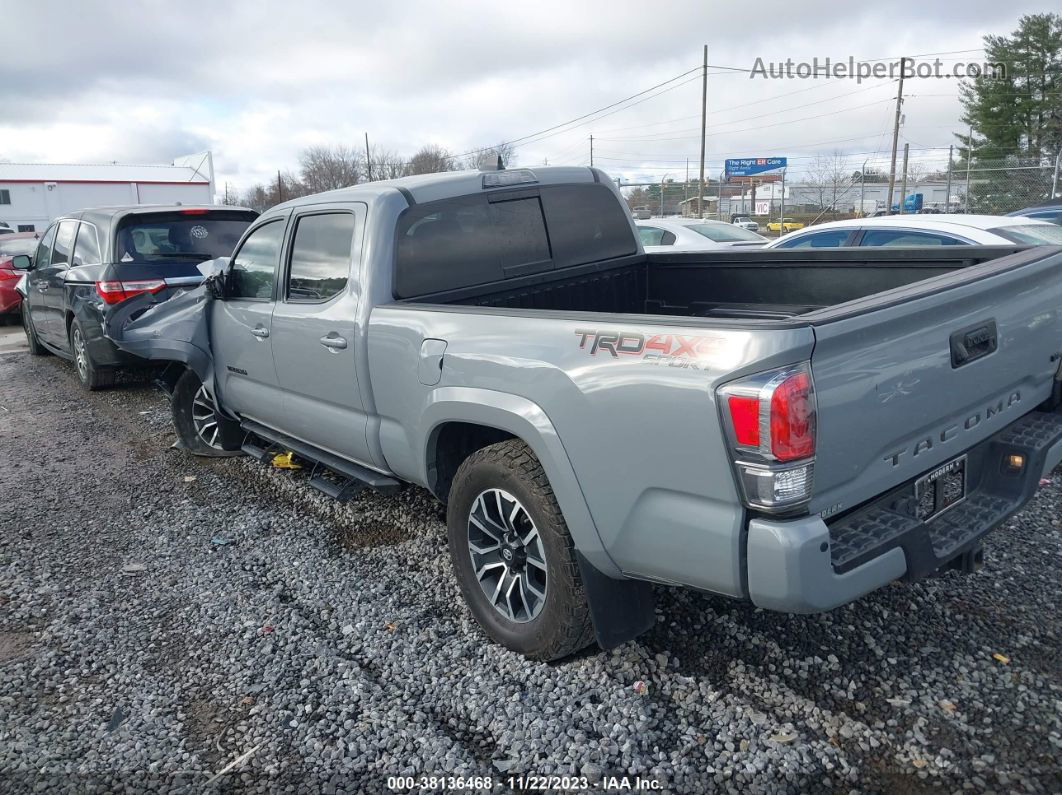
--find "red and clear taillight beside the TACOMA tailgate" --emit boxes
[719,364,816,512]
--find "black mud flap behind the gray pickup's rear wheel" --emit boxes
[576,550,656,650]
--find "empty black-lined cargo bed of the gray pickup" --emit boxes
[406,246,1022,322]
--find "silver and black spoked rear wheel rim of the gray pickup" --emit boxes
[468,488,548,623]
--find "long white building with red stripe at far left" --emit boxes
[0,152,215,232]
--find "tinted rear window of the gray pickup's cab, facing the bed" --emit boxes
[394,184,637,298]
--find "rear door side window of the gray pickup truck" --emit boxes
[287,212,354,303]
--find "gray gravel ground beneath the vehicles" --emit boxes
[0,353,1062,793]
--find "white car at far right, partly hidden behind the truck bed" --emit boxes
[766,214,1062,248]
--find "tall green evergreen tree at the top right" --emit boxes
[956,14,1062,212]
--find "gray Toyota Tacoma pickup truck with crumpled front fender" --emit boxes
[107,168,1062,659]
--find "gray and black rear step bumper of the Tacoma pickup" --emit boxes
[747,412,1062,612]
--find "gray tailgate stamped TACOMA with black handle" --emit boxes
[810,248,1062,516]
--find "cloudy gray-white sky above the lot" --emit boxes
[0,0,1044,189]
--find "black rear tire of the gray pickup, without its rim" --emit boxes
[446,439,594,660]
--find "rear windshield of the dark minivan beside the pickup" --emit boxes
[114,209,256,264]
